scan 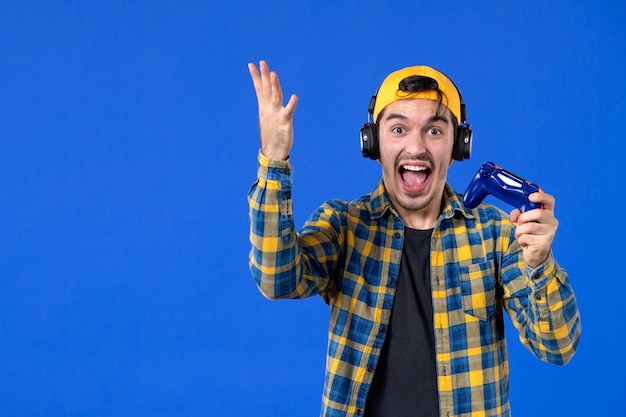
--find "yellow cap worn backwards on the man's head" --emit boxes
[373,65,464,124]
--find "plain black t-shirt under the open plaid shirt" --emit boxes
[365,228,439,417]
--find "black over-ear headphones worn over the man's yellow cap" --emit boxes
[361,80,472,161]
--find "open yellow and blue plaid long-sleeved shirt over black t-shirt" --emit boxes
[248,154,580,417]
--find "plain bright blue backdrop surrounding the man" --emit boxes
[0,0,626,416]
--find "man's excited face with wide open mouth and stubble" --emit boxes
[378,99,455,217]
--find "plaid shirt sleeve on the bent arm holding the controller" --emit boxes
[501,232,581,365]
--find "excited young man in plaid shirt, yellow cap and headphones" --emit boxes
[249,61,580,417]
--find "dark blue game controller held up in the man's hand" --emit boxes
[463,162,541,212]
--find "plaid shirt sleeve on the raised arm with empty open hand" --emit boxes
[248,152,334,299]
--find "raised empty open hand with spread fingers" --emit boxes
[248,61,298,160]
